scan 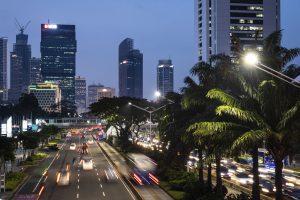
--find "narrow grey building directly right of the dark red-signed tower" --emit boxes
[75,76,86,114]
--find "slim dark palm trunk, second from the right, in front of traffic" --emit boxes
[252,146,260,200]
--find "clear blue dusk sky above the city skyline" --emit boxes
[0,0,300,99]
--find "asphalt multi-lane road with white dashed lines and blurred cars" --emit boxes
[17,136,136,200]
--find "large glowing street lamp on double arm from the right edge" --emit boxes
[243,52,300,88]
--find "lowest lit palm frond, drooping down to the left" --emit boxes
[231,130,269,151]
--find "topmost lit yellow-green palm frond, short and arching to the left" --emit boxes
[206,89,241,107]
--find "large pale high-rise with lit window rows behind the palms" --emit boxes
[195,0,280,62]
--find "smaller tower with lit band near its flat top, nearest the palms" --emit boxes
[157,59,174,96]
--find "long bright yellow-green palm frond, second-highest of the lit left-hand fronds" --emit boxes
[216,105,269,129]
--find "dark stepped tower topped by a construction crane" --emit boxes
[8,29,31,103]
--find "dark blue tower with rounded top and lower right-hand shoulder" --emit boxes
[119,38,143,98]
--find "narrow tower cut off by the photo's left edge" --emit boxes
[0,37,7,102]
